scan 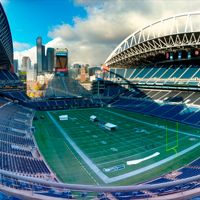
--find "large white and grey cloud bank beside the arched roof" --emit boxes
[13,0,200,65]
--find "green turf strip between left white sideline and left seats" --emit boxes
[34,113,95,184]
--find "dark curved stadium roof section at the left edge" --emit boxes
[0,4,13,69]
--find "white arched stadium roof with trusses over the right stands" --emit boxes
[105,11,200,66]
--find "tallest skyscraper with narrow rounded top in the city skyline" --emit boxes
[36,37,45,73]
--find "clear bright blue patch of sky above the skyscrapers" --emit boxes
[3,0,87,46]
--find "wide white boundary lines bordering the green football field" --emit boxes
[47,109,200,183]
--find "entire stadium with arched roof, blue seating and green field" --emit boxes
[0,1,200,200]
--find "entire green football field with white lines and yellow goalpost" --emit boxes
[34,108,200,185]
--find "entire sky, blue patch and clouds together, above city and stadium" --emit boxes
[1,0,200,65]
